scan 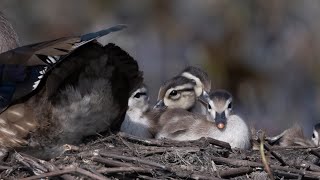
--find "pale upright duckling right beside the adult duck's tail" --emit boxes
[120,86,153,138]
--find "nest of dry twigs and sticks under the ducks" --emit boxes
[0,133,320,180]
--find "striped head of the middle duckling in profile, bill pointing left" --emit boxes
[154,76,197,109]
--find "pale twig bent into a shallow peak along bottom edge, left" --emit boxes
[21,167,108,180]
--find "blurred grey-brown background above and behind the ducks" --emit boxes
[0,0,320,137]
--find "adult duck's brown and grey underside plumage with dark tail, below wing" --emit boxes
[0,25,143,158]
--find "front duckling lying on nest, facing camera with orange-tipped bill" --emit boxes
[156,90,251,149]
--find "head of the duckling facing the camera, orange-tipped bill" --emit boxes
[207,90,232,129]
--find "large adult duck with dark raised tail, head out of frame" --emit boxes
[0,25,143,158]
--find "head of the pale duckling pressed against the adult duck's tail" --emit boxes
[128,85,149,112]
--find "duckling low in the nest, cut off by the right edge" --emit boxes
[266,123,320,147]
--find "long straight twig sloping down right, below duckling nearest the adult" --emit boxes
[99,152,170,170]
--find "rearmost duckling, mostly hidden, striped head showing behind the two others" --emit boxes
[180,66,211,115]
